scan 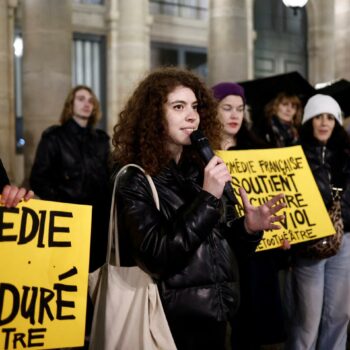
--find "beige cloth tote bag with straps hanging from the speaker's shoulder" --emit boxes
[89,164,176,350]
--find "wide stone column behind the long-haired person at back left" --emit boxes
[22,0,72,176]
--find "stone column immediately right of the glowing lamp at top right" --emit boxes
[306,0,337,84]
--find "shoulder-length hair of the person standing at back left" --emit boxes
[60,85,102,125]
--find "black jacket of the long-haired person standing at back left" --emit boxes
[30,119,110,204]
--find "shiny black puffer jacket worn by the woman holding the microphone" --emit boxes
[116,161,261,321]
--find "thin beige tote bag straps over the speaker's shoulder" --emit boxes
[106,163,160,266]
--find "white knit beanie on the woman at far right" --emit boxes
[302,94,343,125]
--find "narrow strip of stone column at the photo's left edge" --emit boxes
[0,0,17,180]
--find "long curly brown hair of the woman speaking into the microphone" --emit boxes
[112,67,221,175]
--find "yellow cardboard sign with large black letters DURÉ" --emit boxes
[0,199,92,349]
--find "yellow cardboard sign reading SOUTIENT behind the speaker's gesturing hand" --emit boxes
[216,146,335,251]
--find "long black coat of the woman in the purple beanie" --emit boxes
[228,143,289,350]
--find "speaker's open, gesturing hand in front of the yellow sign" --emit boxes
[239,188,286,233]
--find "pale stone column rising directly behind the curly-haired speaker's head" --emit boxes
[118,0,151,109]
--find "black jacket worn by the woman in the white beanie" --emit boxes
[302,140,350,233]
